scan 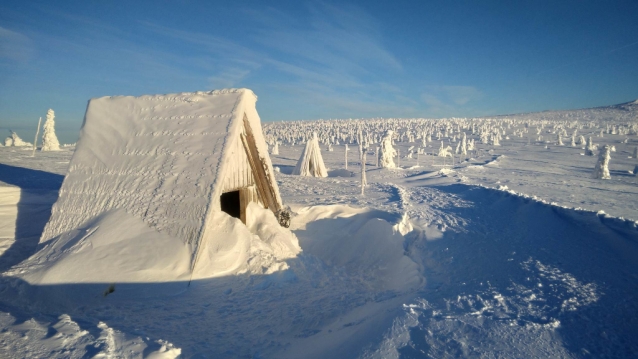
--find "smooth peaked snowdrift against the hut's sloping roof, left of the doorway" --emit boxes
[14,209,190,284]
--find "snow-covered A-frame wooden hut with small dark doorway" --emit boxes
[40,89,282,247]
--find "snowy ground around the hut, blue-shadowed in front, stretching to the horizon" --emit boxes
[0,103,638,358]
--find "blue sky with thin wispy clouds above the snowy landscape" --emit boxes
[0,0,638,142]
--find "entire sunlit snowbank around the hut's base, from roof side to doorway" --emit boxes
[10,204,301,284]
